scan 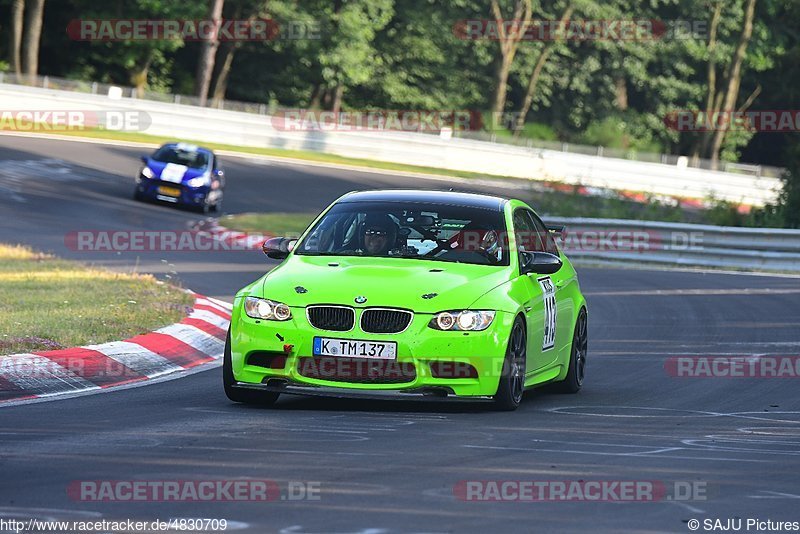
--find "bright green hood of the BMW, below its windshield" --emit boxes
[254,256,508,313]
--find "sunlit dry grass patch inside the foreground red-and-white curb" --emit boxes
[0,243,193,355]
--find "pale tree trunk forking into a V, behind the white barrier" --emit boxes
[491,0,532,118]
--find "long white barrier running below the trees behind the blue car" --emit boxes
[0,84,781,206]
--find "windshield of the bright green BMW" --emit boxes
[295,202,508,265]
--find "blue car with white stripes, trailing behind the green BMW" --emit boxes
[133,143,225,213]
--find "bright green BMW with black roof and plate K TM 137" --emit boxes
[223,190,587,410]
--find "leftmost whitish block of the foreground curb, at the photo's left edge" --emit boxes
[0,354,99,397]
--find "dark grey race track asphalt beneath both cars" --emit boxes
[0,132,800,533]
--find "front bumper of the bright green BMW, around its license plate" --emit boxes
[231,300,514,399]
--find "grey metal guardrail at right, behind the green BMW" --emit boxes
[546,217,800,273]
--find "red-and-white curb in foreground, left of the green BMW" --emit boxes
[0,293,231,405]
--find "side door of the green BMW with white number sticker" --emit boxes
[513,208,555,375]
